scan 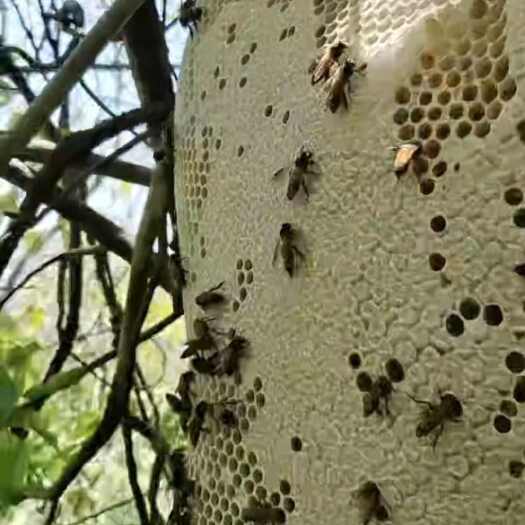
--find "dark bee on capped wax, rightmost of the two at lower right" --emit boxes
[407,388,463,449]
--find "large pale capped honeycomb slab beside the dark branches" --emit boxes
[176,0,525,525]
